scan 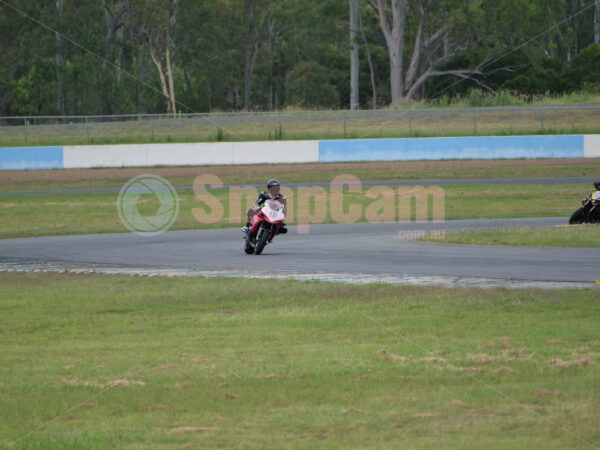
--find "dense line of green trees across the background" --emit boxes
[0,0,600,116]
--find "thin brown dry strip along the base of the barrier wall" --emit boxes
[2,158,600,182]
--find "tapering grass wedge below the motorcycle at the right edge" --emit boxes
[423,224,600,248]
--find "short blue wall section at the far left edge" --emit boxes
[0,147,63,170]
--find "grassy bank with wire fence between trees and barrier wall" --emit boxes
[0,105,600,147]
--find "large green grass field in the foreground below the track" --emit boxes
[0,273,600,449]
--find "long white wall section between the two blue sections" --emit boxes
[63,141,319,168]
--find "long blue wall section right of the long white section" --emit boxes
[319,135,584,162]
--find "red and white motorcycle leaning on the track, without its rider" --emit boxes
[244,200,285,255]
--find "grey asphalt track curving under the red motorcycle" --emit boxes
[0,217,600,287]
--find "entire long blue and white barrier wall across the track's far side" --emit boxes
[0,135,600,170]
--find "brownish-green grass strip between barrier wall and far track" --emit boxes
[0,158,600,192]
